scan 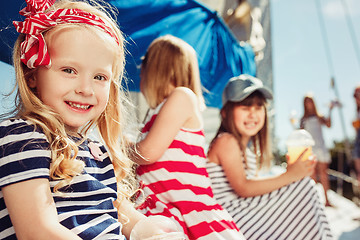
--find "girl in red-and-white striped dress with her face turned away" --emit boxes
[134,35,243,240]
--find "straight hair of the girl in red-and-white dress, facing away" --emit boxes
[140,35,205,109]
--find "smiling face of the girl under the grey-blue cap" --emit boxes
[233,104,265,142]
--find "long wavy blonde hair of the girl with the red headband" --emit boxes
[13,0,131,197]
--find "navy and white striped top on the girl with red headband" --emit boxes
[0,119,125,239]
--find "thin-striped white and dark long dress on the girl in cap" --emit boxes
[207,149,333,240]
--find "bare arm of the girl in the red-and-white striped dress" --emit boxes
[132,87,201,165]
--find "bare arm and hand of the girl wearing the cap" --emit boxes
[208,133,315,197]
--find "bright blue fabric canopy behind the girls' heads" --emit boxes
[0,0,256,107]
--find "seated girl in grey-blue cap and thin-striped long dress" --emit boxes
[207,75,332,240]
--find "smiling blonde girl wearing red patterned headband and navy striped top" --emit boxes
[0,0,176,240]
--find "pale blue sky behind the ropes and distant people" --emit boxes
[0,0,360,154]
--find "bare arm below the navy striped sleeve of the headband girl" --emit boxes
[2,178,81,240]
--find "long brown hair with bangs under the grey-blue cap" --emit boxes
[210,91,272,169]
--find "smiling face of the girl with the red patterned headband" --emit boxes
[29,28,115,133]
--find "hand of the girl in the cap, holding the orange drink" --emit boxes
[286,148,316,181]
